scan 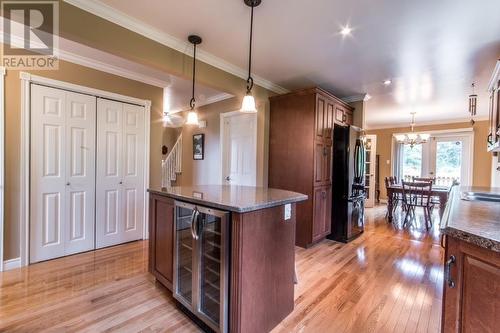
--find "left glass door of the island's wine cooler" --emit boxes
[174,204,195,309]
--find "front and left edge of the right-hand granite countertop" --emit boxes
[440,186,500,252]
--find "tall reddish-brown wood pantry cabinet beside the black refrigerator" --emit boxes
[269,88,353,247]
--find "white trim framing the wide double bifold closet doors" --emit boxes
[19,72,151,266]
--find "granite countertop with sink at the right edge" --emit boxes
[441,187,500,252]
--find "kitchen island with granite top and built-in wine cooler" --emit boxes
[148,185,307,332]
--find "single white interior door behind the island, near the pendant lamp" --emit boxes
[221,113,257,186]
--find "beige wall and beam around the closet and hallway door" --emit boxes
[4,1,273,259]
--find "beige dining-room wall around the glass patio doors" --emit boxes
[367,121,491,198]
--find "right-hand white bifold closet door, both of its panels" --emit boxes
[96,99,145,248]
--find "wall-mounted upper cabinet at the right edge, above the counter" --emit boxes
[488,60,500,152]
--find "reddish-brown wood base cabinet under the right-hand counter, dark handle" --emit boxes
[441,237,500,333]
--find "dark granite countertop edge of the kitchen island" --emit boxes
[148,189,308,213]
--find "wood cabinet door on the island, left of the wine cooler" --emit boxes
[149,194,175,291]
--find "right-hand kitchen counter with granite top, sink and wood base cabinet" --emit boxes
[441,187,500,332]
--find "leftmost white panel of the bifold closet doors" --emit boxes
[30,85,66,263]
